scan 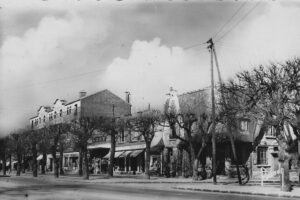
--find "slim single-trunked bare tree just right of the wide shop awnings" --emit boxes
[128,110,161,179]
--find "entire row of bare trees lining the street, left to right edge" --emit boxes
[1,59,300,190]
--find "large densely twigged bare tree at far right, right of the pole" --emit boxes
[221,59,300,191]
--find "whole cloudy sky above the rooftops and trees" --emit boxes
[0,0,300,135]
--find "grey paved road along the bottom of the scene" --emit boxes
[0,178,291,200]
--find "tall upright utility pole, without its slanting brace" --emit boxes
[207,38,217,184]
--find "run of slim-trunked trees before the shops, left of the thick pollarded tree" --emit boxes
[0,110,161,179]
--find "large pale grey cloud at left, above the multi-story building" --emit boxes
[0,11,109,134]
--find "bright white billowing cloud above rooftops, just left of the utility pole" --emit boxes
[101,38,210,111]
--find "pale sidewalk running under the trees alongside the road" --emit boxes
[4,173,300,198]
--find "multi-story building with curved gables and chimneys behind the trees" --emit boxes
[30,90,131,173]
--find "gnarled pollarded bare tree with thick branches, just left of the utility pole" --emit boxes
[164,96,211,180]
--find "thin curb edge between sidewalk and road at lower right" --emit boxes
[171,187,300,198]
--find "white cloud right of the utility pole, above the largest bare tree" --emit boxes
[216,2,300,77]
